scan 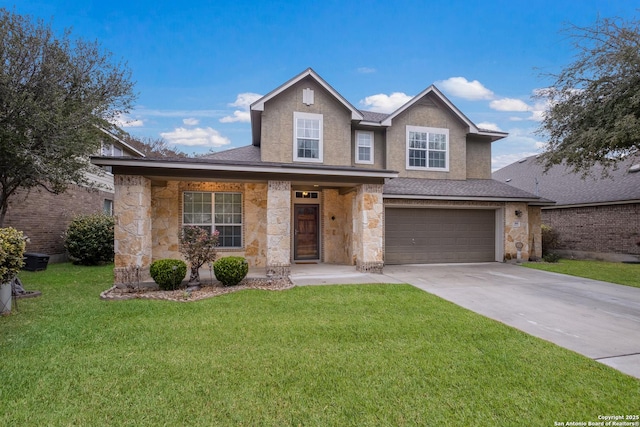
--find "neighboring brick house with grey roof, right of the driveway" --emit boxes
[493,156,640,261]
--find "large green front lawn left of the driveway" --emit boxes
[0,264,640,426]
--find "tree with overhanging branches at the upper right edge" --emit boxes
[538,15,640,175]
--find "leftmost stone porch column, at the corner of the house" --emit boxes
[113,175,152,285]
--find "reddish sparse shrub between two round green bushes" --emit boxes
[180,226,220,283]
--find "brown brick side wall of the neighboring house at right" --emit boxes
[542,203,640,255]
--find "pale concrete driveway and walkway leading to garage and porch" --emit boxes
[291,263,640,378]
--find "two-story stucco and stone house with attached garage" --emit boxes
[93,69,549,283]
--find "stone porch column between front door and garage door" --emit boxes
[353,184,384,273]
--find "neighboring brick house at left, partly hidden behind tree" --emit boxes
[4,131,144,262]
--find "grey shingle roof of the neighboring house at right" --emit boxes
[492,156,640,206]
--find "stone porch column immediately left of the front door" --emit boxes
[267,181,291,277]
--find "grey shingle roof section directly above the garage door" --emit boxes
[384,178,551,204]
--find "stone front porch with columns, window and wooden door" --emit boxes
[114,175,383,284]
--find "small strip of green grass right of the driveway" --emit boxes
[523,259,640,288]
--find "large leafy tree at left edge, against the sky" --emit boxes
[0,9,135,227]
